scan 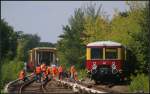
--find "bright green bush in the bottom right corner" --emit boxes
[129,74,149,93]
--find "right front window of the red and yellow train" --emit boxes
[106,48,118,59]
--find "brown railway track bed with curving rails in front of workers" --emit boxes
[6,74,110,94]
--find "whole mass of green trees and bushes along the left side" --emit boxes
[0,19,40,91]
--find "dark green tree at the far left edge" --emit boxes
[0,19,17,60]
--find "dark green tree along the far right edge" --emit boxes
[135,1,150,73]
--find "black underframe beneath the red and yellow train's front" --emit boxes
[89,67,125,84]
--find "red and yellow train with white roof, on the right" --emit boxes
[86,41,126,84]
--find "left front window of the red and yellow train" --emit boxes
[91,48,103,59]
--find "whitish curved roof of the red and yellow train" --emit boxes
[87,41,122,47]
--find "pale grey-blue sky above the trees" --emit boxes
[1,1,128,43]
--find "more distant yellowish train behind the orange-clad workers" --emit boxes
[27,47,58,71]
